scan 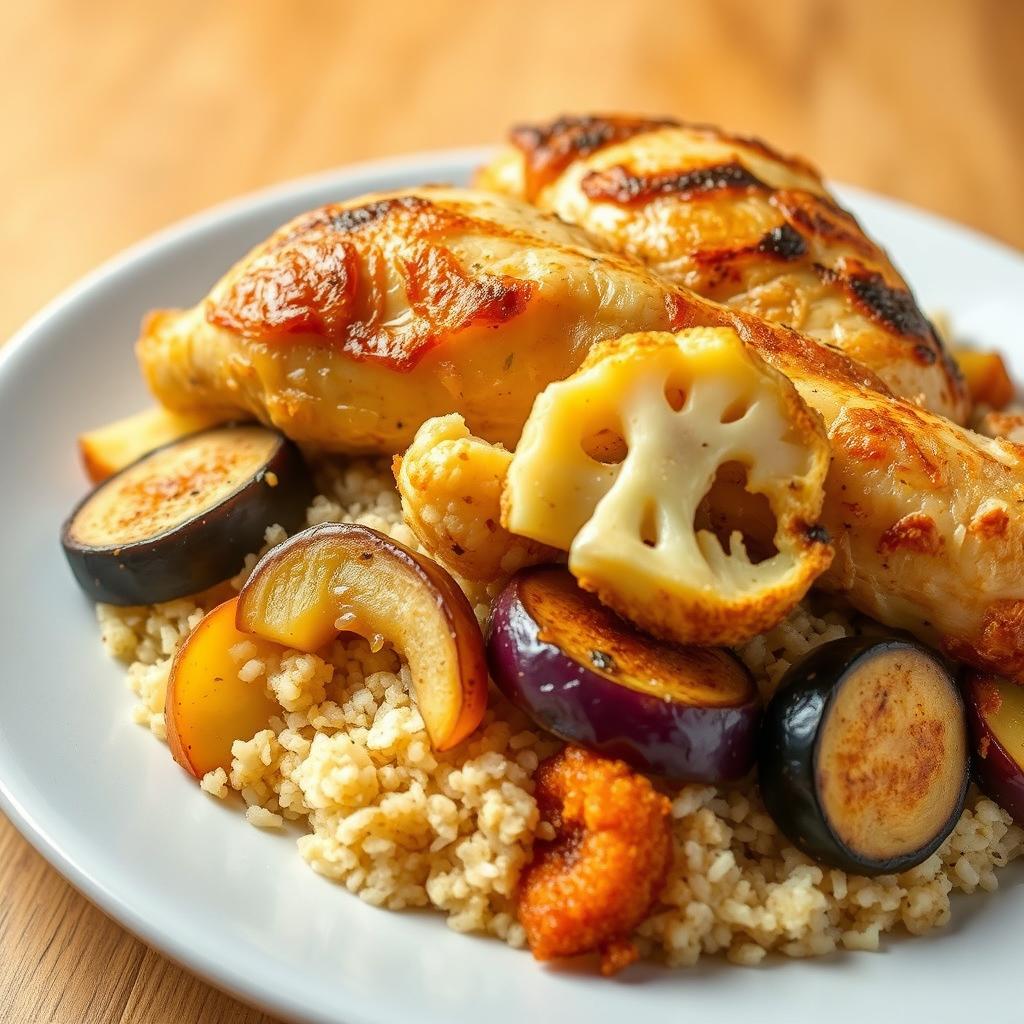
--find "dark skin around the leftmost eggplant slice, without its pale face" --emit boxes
[60,423,315,606]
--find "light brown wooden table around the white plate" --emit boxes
[0,0,1024,1024]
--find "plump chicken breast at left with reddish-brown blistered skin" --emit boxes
[137,187,671,454]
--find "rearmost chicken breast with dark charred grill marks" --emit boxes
[477,117,969,423]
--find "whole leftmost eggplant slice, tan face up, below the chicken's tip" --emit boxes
[60,424,313,604]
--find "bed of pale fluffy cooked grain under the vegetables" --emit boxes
[98,462,1024,965]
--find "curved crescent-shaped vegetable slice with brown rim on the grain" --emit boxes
[238,523,487,751]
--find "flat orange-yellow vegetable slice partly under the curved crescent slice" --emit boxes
[164,598,282,778]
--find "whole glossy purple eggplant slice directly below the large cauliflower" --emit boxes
[487,565,761,782]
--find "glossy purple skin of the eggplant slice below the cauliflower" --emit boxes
[487,566,761,782]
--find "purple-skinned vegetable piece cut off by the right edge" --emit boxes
[964,673,1024,822]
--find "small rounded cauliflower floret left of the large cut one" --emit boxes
[393,414,558,583]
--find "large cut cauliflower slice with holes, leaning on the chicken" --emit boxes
[503,328,831,644]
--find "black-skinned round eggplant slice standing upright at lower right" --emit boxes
[759,637,969,874]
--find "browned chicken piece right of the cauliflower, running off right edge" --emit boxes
[673,293,1024,682]
